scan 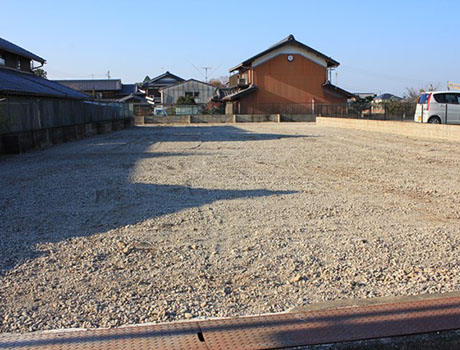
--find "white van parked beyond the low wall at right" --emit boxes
[414,91,460,124]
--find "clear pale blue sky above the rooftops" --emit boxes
[0,0,460,95]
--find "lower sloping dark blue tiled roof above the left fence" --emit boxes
[0,68,89,100]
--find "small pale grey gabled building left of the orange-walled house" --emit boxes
[160,79,217,105]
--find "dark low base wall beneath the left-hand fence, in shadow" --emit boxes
[0,118,134,154]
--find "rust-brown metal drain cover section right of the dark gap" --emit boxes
[200,298,460,350]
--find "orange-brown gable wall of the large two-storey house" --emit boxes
[240,54,346,106]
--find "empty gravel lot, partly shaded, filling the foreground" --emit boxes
[0,123,460,332]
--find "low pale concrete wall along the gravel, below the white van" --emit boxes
[316,117,460,141]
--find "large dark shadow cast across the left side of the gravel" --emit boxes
[0,126,303,276]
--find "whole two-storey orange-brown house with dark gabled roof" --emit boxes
[223,34,353,114]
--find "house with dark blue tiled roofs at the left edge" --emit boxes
[0,38,88,100]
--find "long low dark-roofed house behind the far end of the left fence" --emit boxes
[54,79,139,101]
